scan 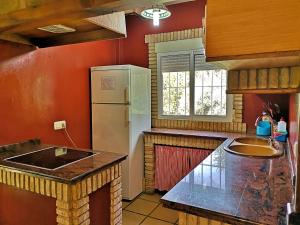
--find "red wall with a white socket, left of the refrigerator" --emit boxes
[0,41,117,147]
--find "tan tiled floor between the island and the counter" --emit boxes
[122,194,178,225]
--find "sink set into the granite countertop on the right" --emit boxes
[224,137,283,158]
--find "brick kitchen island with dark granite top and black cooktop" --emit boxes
[0,140,126,225]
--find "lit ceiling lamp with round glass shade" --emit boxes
[141,5,171,26]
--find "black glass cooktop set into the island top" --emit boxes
[5,147,95,170]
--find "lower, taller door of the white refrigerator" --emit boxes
[92,104,143,200]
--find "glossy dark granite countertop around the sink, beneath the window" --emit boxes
[151,129,293,225]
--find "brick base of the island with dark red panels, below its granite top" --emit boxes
[0,164,122,225]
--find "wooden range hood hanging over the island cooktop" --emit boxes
[0,0,195,47]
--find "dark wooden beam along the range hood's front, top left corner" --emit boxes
[0,0,120,32]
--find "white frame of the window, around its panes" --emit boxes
[157,50,233,122]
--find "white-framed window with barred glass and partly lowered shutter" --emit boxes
[158,51,232,121]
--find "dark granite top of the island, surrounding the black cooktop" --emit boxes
[0,140,126,183]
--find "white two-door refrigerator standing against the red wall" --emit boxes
[91,65,151,200]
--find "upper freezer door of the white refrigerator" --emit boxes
[91,69,130,104]
